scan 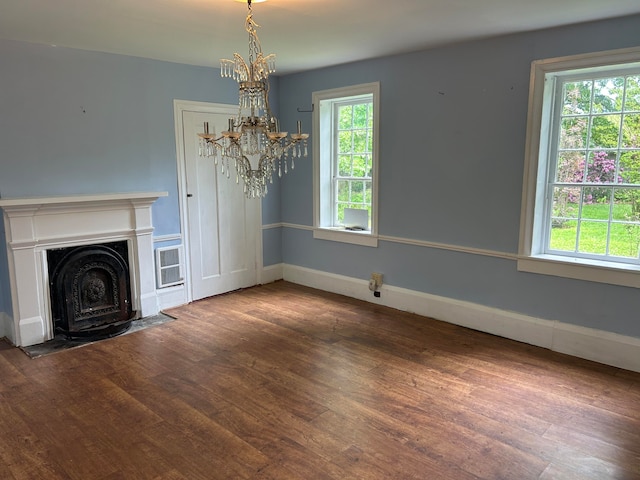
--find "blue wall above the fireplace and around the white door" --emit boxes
[0,40,280,314]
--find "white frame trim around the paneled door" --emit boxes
[173,99,264,303]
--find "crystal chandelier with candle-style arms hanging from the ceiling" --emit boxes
[198,0,309,198]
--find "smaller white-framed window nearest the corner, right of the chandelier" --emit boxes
[313,83,379,246]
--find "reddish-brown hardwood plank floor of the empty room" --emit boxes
[0,282,640,480]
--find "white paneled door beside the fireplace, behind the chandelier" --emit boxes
[182,107,261,300]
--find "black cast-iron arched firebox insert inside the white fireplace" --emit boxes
[47,241,133,338]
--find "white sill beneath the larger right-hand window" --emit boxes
[518,255,640,288]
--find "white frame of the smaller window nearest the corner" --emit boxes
[312,82,380,247]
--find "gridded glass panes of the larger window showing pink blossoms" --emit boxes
[545,71,640,263]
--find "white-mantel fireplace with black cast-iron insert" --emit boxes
[0,192,167,346]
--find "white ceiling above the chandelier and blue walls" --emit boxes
[0,0,640,73]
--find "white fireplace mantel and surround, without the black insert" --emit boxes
[0,192,167,346]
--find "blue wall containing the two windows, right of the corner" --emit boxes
[280,16,640,337]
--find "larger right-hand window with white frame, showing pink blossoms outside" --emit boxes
[518,49,640,287]
